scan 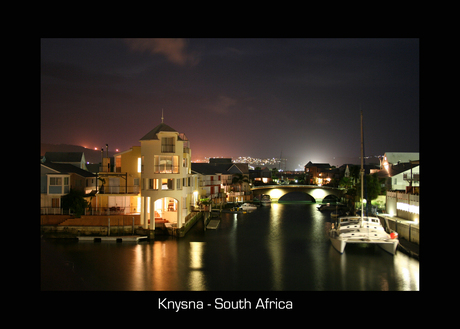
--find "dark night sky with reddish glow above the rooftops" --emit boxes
[40,39,420,169]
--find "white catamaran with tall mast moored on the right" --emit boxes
[329,112,399,255]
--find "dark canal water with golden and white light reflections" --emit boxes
[41,203,419,291]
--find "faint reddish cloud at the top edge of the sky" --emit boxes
[125,38,198,66]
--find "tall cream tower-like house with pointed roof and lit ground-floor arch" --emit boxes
[140,123,199,230]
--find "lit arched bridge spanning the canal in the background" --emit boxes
[251,185,344,203]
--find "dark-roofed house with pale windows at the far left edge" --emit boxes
[40,162,96,214]
